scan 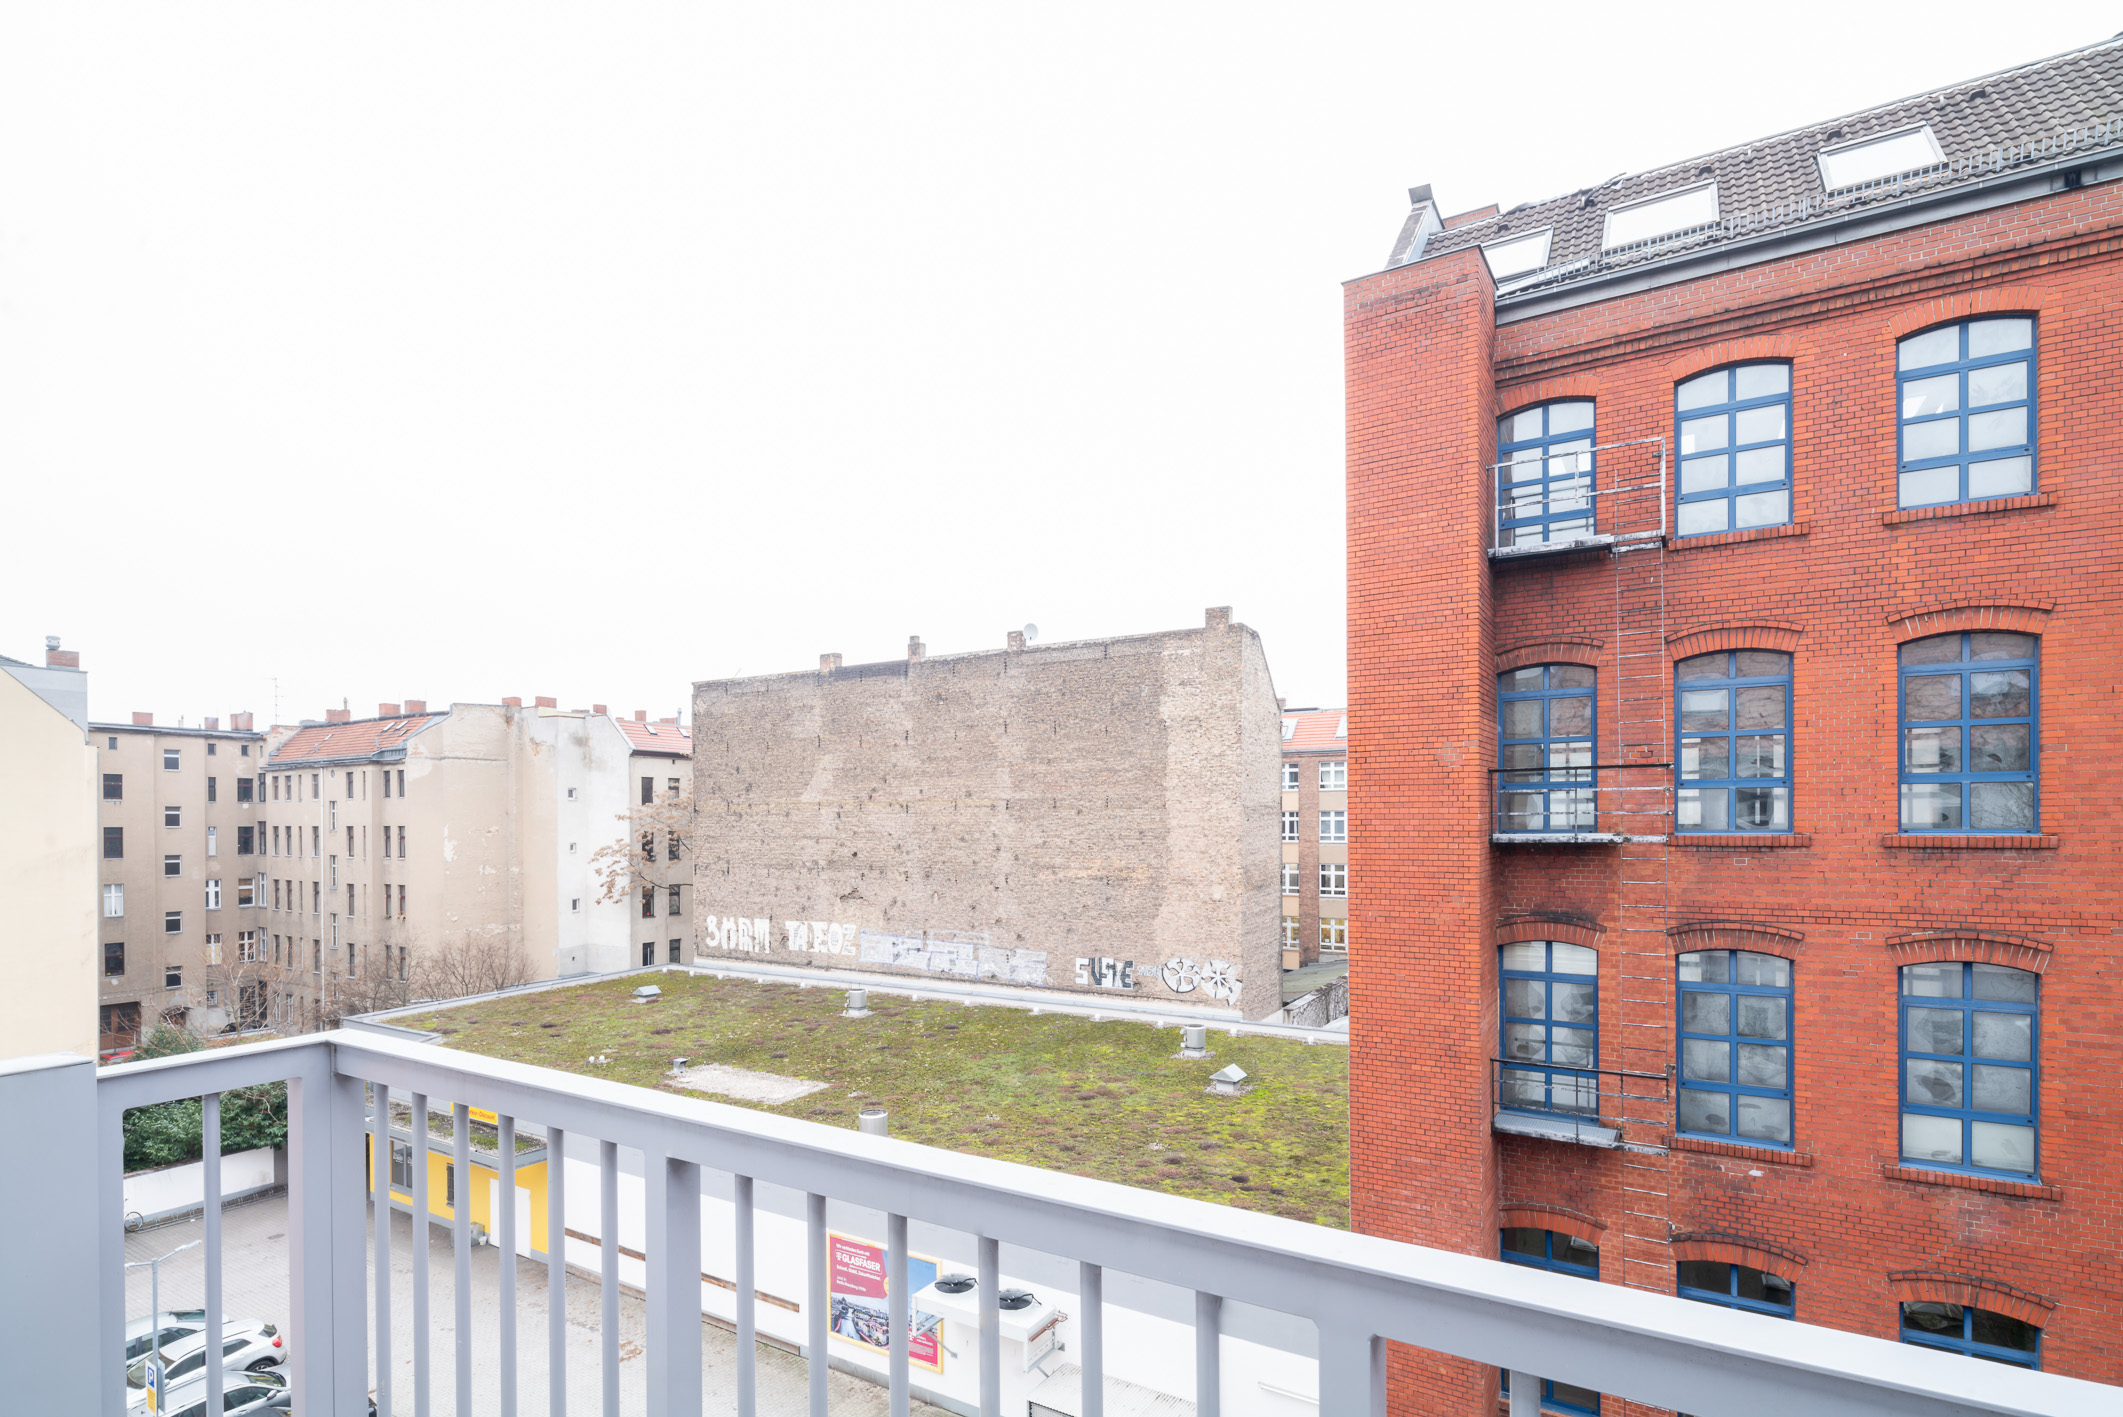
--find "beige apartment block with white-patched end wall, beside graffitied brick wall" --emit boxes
[257,699,690,1028]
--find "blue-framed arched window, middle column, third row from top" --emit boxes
[1677,950,1792,1147]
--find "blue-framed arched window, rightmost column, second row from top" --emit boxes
[1898,631,2042,833]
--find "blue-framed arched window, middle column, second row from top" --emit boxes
[1673,650,1792,831]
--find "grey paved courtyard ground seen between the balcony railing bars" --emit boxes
[125,1196,940,1417]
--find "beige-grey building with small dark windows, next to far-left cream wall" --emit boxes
[89,712,272,1052]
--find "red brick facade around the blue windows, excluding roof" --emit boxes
[1346,166,2123,1413]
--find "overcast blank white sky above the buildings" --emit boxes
[0,0,2123,722]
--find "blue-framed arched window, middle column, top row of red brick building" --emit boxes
[1673,363,1792,535]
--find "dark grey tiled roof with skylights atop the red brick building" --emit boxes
[1393,36,2123,293]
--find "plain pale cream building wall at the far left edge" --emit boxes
[0,639,96,1062]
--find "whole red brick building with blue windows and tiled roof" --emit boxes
[1346,36,2123,1413]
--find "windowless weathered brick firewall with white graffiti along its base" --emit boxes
[692,612,1282,1018]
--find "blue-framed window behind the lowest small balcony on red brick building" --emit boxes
[1497,939,1599,1117]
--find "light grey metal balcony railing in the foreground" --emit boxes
[0,1032,2119,1417]
